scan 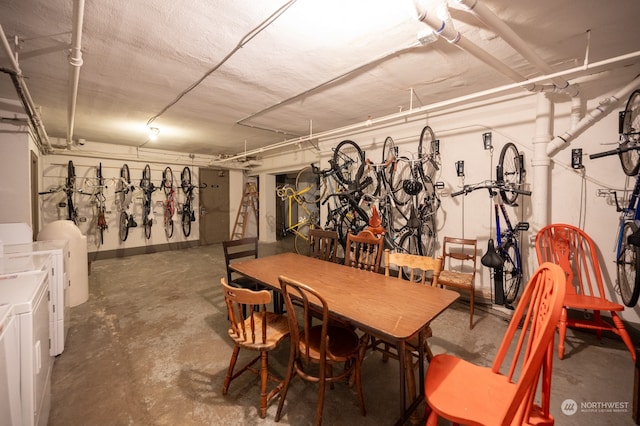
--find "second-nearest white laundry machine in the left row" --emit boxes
[0,272,53,426]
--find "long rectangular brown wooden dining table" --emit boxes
[231,253,459,424]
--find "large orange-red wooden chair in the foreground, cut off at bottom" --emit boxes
[424,262,566,426]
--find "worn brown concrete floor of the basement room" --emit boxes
[49,243,634,426]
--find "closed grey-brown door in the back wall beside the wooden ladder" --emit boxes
[199,169,230,245]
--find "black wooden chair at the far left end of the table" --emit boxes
[222,237,282,313]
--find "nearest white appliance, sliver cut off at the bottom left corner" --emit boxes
[0,304,22,426]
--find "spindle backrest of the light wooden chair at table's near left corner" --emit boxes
[220,278,271,344]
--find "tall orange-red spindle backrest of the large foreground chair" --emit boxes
[491,262,566,424]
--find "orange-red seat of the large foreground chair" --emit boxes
[425,354,516,425]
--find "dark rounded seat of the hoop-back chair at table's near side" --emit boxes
[300,325,360,362]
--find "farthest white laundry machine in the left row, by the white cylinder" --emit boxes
[4,240,71,356]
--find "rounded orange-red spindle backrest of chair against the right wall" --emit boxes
[536,224,605,299]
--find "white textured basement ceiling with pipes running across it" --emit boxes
[0,0,640,158]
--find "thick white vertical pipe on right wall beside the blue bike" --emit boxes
[531,93,553,232]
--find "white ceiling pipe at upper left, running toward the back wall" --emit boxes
[67,0,84,146]
